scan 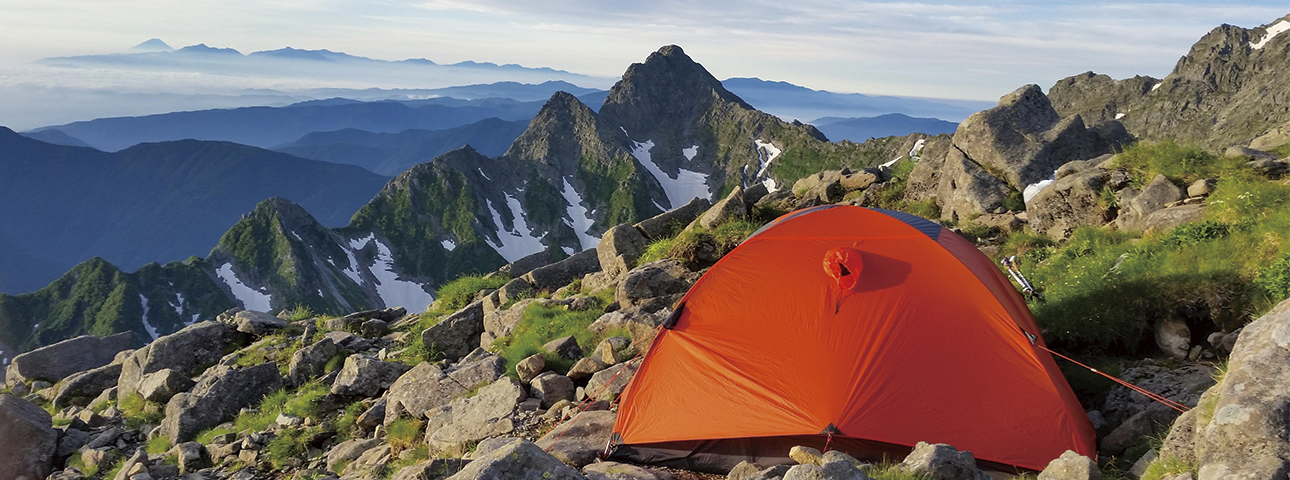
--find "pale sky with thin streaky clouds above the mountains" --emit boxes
[0,0,1290,99]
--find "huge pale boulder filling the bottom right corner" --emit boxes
[1161,302,1290,479]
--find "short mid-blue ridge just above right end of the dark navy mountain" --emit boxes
[273,119,528,177]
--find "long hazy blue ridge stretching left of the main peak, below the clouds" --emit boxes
[35,99,542,151]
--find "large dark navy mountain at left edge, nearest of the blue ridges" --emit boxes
[0,128,387,293]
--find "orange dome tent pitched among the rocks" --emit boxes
[610,205,1097,472]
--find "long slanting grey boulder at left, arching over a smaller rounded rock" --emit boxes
[117,321,241,399]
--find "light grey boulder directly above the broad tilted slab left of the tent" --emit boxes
[384,354,506,425]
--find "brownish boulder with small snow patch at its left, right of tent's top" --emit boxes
[1026,161,1111,240]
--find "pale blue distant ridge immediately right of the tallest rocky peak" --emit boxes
[721,77,996,121]
